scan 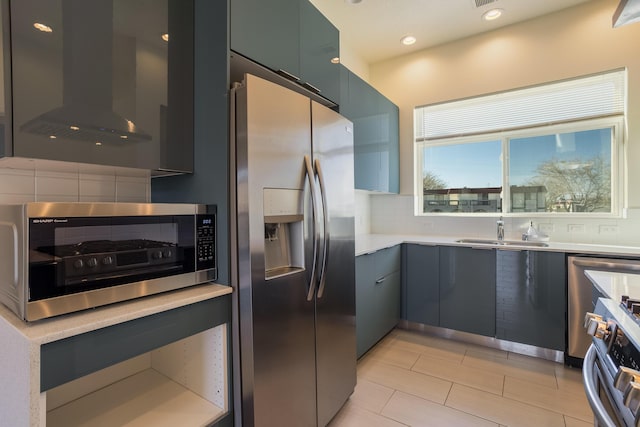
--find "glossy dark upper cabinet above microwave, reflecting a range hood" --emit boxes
[3,0,194,172]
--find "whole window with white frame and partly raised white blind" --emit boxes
[415,71,625,215]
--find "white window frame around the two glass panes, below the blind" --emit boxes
[414,114,627,218]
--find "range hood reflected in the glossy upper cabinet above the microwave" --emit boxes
[21,0,152,144]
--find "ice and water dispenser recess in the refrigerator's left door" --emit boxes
[263,188,304,280]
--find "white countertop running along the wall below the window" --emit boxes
[355,234,640,257]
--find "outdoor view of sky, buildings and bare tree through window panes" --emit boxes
[422,127,613,213]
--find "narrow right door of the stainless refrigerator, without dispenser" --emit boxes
[312,102,356,426]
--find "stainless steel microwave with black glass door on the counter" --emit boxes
[0,202,217,321]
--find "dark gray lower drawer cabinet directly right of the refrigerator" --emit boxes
[356,245,400,357]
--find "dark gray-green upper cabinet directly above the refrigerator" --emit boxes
[230,0,340,102]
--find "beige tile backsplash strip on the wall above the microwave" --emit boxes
[0,159,151,204]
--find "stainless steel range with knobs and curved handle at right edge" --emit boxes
[582,298,640,427]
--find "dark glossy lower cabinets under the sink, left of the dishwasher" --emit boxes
[402,244,567,351]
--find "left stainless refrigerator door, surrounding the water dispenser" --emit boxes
[235,75,317,426]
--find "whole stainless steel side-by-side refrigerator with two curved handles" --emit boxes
[231,74,356,427]
